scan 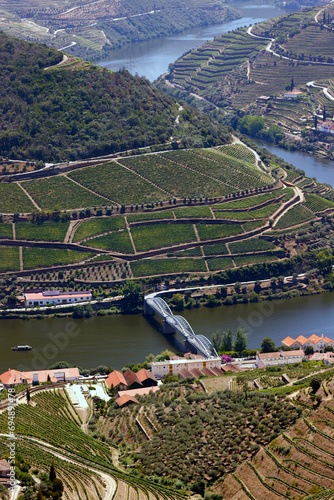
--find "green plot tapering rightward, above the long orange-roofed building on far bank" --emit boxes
[23,247,93,269]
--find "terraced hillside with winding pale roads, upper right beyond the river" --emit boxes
[160,4,334,157]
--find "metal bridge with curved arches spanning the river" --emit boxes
[144,293,218,358]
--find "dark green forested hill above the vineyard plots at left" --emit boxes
[0,33,228,162]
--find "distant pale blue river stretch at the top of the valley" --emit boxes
[95,0,285,81]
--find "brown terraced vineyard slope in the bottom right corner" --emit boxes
[216,394,334,500]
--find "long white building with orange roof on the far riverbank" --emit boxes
[23,290,92,307]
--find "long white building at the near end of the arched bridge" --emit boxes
[152,357,223,378]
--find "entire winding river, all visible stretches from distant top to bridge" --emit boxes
[0,2,334,372]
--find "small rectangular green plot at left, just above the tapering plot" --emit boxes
[15,221,68,241]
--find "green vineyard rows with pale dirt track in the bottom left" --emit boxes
[0,389,186,500]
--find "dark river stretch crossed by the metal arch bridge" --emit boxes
[0,293,334,373]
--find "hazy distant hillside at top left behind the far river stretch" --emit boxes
[0,0,240,61]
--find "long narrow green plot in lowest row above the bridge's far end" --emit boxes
[131,258,206,277]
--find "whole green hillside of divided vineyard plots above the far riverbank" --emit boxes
[0,139,334,292]
